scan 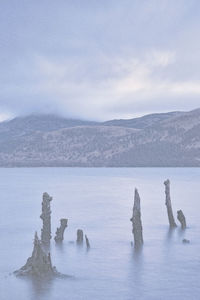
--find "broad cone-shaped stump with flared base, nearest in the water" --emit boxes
[14,232,59,277]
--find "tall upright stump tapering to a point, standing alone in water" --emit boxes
[130,189,143,248]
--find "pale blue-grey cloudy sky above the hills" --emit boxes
[0,0,200,121]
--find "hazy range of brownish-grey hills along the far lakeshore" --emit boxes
[0,109,200,167]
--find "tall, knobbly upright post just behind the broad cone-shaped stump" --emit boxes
[40,193,52,249]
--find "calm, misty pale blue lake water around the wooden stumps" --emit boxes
[0,168,200,300]
